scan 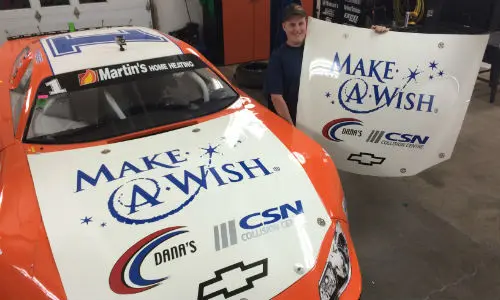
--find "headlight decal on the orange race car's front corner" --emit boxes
[319,222,351,300]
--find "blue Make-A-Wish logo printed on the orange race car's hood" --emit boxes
[76,141,280,224]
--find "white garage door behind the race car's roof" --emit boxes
[0,0,153,43]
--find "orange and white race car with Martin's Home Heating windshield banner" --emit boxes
[0,26,361,300]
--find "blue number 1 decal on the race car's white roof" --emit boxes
[43,29,168,57]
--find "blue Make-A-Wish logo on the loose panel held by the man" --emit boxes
[325,52,444,114]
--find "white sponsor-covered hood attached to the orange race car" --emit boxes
[28,110,331,300]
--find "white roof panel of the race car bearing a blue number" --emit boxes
[40,26,183,75]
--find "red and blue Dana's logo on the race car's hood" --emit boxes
[109,226,197,294]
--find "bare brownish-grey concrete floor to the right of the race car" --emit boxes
[221,66,500,300]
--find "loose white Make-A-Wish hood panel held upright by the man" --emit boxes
[297,18,489,177]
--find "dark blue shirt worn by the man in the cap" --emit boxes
[264,43,304,124]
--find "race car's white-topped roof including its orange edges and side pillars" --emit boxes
[0,26,205,149]
